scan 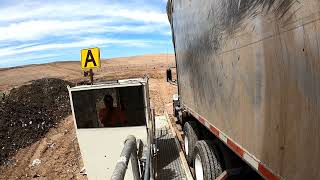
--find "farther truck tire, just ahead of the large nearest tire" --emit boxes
[183,121,199,165]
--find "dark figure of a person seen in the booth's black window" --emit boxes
[99,94,125,127]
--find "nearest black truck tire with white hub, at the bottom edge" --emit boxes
[193,140,223,180]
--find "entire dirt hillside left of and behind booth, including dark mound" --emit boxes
[0,54,177,180]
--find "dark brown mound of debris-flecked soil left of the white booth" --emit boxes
[0,78,72,164]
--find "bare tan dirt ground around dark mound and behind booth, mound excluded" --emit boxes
[0,54,176,179]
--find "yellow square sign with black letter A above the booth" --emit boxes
[81,48,101,70]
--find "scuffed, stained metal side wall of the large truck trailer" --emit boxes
[167,0,320,179]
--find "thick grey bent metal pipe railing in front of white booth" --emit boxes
[111,135,140,180]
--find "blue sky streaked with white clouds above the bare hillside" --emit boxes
[0,0,173,67]
